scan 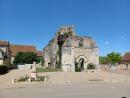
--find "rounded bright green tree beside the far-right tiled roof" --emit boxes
[107,52,121,65]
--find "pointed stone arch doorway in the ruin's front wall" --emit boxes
[75,55,88,71]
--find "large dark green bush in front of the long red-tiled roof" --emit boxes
[13,52,37,65]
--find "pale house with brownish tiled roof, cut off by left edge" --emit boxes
[0,41,10,65]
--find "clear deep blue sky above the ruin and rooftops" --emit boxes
[0,0,130,55]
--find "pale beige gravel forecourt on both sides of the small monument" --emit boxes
[0,70,130,87]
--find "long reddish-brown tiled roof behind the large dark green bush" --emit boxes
[10,45,36,56]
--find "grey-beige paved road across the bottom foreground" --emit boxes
[0,83,130,98]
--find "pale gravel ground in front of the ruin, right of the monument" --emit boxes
[39,71,130,84]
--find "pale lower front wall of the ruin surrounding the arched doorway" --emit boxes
[62,47,99,71]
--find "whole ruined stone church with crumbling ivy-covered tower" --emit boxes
[43,26,99,72]
